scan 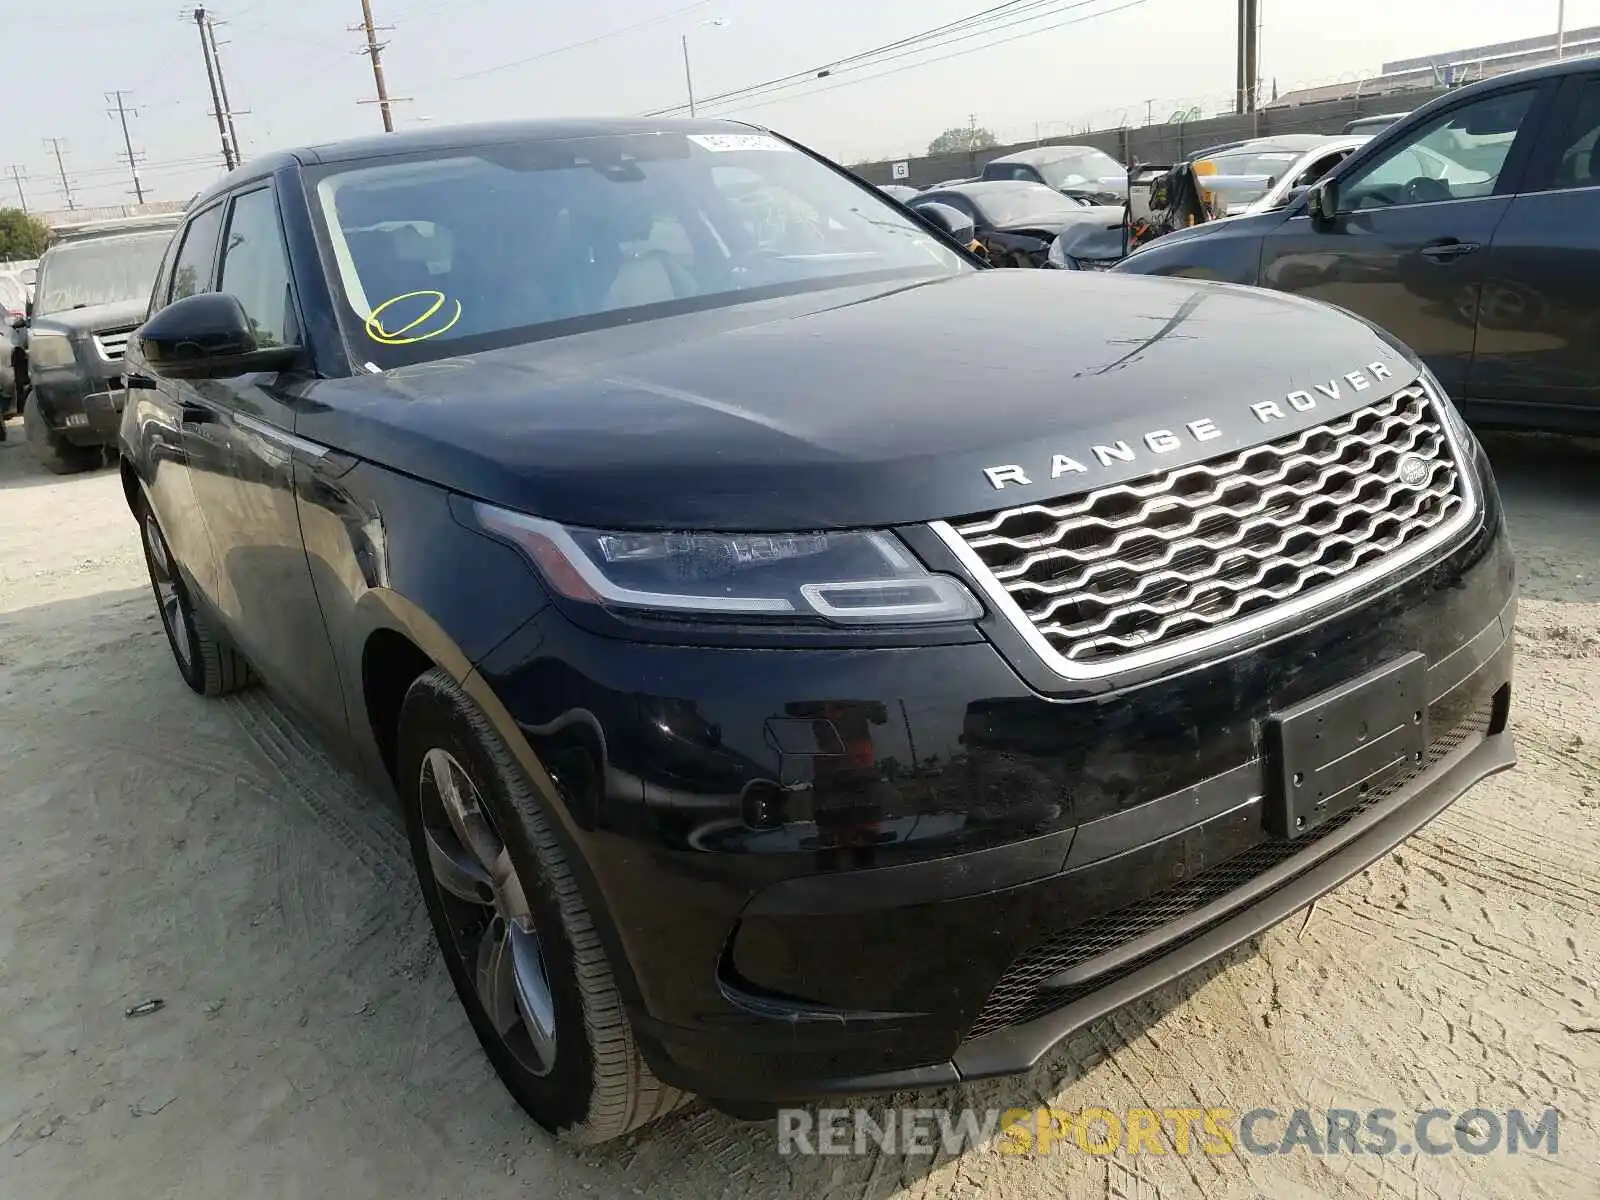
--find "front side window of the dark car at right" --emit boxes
[1339,88,1538,213]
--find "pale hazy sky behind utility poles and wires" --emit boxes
[0,0,1600,210]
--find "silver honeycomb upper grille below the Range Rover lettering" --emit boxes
[955,387,1467,674]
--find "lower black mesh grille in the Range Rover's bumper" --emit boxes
[968,699,1494,1037]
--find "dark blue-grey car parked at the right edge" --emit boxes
[1117,58,1600,434]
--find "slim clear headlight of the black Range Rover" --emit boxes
[475,504,982,626]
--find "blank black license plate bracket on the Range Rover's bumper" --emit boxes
[1266,653,1427,838]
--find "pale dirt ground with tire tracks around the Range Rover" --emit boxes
[0,424,1600,1200]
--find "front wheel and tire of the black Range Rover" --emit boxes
[397,669,683,1144]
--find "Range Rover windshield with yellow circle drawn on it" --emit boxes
[314,133,968,366]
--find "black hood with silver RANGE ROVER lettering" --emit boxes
[296,270,1416,530]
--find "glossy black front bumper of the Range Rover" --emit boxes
[478,454,1515,1101]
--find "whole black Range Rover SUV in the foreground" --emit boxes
[122,122,1514,1141]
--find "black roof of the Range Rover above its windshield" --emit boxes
[189,117,768,210]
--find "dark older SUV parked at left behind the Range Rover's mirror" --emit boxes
[22,218,178,475]
